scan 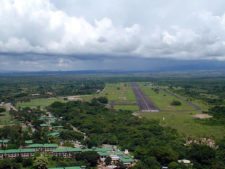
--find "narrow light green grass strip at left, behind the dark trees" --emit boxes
[17,97,64,108]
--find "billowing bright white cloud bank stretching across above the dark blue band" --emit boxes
[0,0,225,61]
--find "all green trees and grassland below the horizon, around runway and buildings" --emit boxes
[0,75,225,169]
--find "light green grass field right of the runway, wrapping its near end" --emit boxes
[140,83,225,139]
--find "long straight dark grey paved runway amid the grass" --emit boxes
[131,83,159,112]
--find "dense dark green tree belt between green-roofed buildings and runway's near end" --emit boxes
[49,99,225,168]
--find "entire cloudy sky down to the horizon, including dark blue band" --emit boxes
[0,0,225,71]
